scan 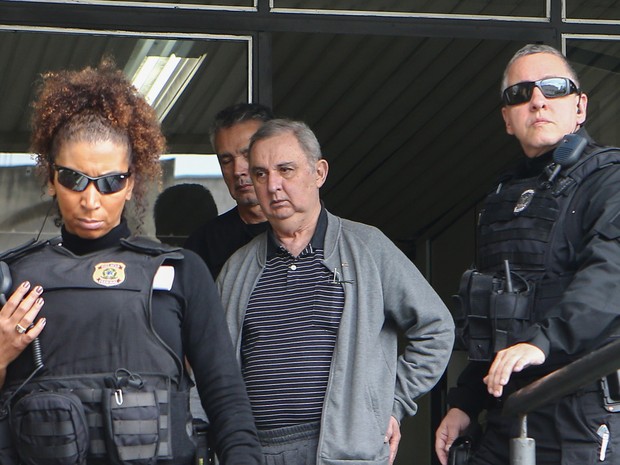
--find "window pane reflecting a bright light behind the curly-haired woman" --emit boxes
[0,31,250,246]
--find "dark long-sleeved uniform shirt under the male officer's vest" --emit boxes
[448,130,620,418]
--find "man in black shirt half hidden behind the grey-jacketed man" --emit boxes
[185,103,273,279]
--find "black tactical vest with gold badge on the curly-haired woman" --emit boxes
[0,239,187,465]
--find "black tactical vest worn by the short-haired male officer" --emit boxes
[455,143,620,361]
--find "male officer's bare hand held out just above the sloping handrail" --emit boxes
[483,342,546,397]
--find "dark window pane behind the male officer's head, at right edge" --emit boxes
[566,37,620,146]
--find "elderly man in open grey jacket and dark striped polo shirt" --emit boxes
[218,120,454,465]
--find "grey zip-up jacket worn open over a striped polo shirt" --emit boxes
[217,213,454,465]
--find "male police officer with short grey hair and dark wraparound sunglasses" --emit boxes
[435,45,620,465]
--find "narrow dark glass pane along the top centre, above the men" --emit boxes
[274,0,546,17]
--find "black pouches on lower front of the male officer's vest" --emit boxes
[454,269,535,362]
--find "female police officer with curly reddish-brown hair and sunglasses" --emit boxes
[0,61,261,465]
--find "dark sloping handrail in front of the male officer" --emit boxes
[503,339,620,416]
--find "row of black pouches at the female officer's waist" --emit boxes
[0,369,179,465]
